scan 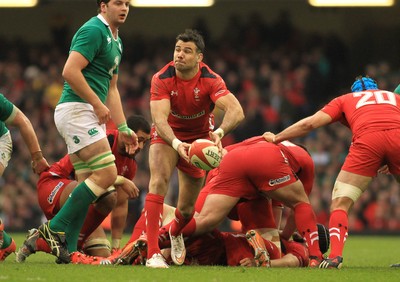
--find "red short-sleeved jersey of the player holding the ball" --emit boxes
[150,61,230,140]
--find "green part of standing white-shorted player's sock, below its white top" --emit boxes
[50,182,97,232]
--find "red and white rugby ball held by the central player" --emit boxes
[189,139,221,171]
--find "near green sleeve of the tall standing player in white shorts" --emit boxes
[71,26,104,62]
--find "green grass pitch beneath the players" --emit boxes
[0,234,400,282]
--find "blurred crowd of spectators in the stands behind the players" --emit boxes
[0,12,400,232]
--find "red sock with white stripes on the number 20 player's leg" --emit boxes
[329,210,349,258]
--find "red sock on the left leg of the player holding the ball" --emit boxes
[144,193,164,259]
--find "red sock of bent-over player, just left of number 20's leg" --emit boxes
[294,203,322,258]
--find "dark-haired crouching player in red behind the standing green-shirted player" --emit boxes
[16,116,150,264]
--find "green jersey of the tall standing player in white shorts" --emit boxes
[58,15,122,104]
